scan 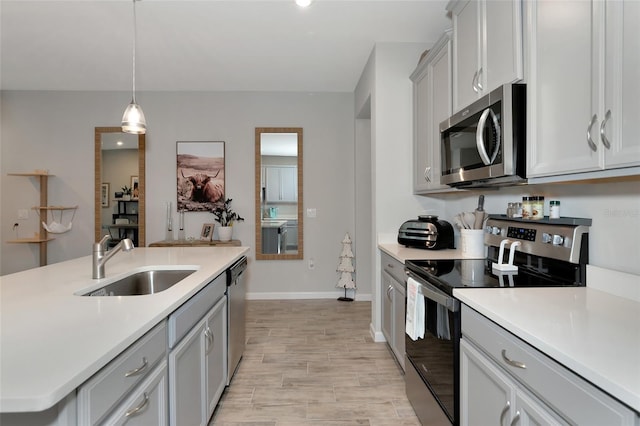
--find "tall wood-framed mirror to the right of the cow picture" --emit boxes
[255,127,304,260]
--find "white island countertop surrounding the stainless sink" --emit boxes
[0,247,249,412]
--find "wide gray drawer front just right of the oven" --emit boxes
[462,305,635,425]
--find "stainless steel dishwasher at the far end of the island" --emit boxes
[227,256,247,386]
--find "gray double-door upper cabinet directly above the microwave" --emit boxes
[447,0,523,112]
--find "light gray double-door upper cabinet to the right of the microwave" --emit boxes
[525,0,640,178]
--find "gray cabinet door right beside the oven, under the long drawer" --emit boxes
[460,339,515,426]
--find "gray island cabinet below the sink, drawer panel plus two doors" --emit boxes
[168,274,227,426]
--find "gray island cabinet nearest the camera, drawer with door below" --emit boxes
[77,321,167,425]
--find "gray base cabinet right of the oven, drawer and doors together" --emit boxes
[460,305,638,426]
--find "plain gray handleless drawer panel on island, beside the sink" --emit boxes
[168,271,227,348]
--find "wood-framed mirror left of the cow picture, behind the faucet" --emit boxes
[94,127,146,247]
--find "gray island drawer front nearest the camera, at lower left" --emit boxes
[78,321,167,425]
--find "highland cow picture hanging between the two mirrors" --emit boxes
[176,141,225,212]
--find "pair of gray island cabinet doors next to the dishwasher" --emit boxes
[169,297,227,426]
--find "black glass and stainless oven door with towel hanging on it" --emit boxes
[405,273,460,425]
